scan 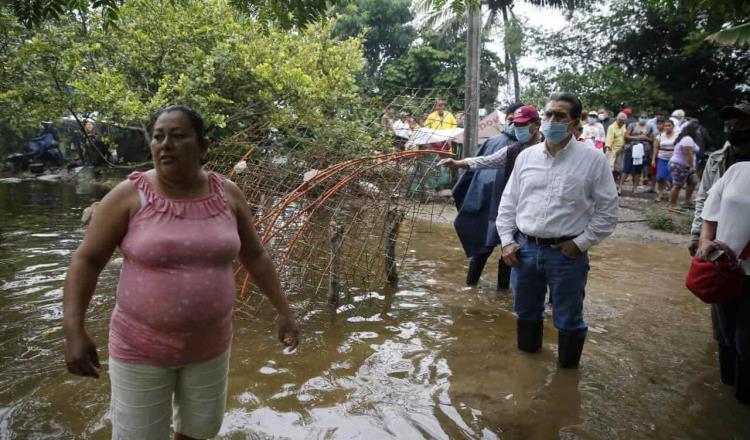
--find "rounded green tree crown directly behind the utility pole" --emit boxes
[382,34,504,108]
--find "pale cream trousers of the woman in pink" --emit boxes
[109,350,229,440]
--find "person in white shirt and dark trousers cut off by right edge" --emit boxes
[695,161,750,403]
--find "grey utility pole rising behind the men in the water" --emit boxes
[463,0,482,157]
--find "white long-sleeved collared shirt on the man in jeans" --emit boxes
[496,137,619,251]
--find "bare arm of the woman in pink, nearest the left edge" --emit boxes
[63,181,140,377]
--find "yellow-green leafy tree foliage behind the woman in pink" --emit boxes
[0,0,363,155]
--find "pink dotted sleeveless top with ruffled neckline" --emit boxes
[109,172,240,366]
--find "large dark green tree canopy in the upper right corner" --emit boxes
[531,0,750,146]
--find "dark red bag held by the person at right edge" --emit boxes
[685,243,750,304]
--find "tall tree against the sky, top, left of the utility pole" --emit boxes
[332,0,417,92]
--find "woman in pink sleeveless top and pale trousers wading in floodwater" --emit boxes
[63,106,299,438]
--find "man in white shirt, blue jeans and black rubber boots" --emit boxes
[497,93,618,368]
